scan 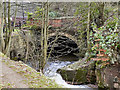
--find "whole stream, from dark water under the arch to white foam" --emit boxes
[44,54,90,89]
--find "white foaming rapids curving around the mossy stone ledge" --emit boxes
[44,61,90,88]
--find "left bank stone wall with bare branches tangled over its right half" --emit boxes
[8,30,41,70]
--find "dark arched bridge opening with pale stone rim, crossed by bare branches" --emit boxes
[48,33,79,55]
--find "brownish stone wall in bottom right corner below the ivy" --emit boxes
[95,64,120,90]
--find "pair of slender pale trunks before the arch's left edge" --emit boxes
[40,1,49,72]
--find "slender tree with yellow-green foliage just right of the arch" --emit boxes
[75,2,91,57]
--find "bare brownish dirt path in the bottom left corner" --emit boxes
[0,57,29,88]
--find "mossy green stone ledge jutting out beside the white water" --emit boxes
[57,61,96,84]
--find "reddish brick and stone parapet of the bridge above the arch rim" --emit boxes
[29,16,79,36]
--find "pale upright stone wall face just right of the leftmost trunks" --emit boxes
[9,31,31,60]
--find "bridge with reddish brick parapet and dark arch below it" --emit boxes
[27,16,85,55]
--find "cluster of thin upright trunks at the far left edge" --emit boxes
[1,0,17,55]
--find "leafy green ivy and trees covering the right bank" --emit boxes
[75,2,119,63]
